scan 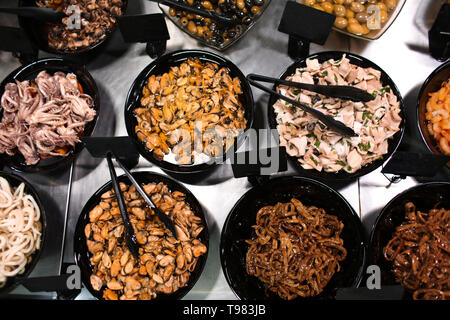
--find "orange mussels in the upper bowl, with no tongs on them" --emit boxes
[134,59,246,164]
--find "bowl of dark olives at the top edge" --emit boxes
[159,0,271,51]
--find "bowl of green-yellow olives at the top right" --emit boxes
[297,0,406,40]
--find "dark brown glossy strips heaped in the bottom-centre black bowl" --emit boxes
[246,198,347,300]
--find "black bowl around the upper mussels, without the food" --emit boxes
[125,50,254,173]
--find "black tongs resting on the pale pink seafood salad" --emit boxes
[247,73,374,137]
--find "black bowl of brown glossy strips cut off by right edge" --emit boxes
[367,182,450,300]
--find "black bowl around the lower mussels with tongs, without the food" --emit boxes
[74,171,209,300]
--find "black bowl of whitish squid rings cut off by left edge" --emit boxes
[0,172,47,295]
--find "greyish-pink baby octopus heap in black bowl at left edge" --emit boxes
[0,71,96,165]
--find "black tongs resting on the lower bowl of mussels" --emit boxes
[106,152,177,259]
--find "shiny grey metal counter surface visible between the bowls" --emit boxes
[0,0,450,300]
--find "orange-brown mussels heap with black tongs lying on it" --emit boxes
[84,183,207,300]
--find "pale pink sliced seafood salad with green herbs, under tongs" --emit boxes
[273,55,402,173]
